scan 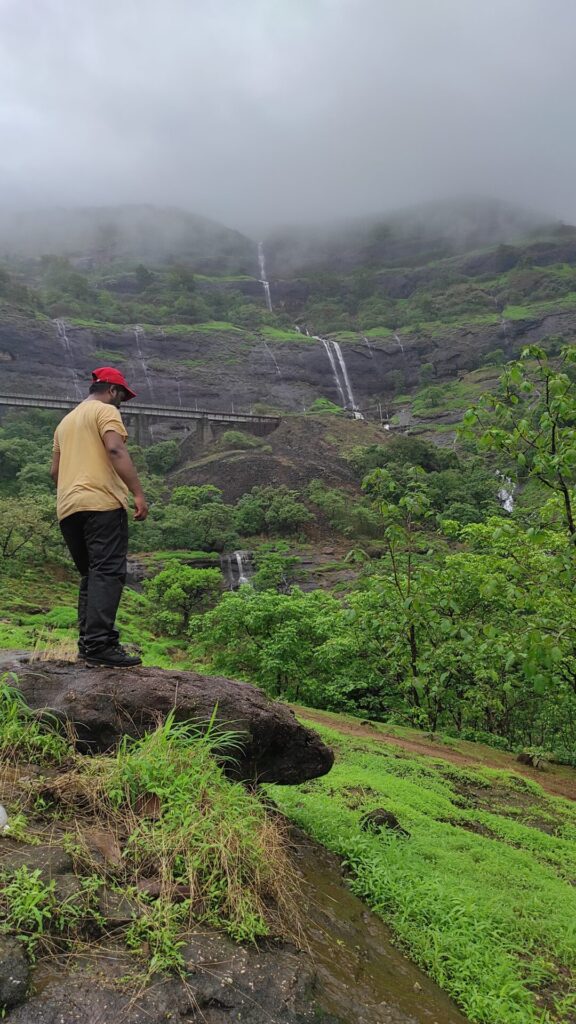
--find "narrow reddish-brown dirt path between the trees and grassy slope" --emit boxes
[292,705,576,800]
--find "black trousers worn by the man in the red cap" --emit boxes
[60,508,128,654]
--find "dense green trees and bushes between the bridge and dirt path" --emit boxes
[0,348,576,761]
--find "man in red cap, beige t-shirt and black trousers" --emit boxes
[50,367,148,669]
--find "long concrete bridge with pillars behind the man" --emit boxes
[0,393,281,444]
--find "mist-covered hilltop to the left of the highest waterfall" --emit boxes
[0,206,257,273]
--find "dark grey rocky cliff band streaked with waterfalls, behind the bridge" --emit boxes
[0,311,576,422]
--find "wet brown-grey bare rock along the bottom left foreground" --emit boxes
[0,806,465,1024]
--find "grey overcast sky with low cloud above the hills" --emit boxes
[0,0,576,231]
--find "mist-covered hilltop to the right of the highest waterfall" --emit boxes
[266,199,563,276]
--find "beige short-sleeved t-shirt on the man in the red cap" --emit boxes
[53,398,128,519]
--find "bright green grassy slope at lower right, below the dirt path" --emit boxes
[271,724,576,1024]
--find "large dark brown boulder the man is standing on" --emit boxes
[0,659,334,784]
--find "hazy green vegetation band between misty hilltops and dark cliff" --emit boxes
[0,226,576,342]
